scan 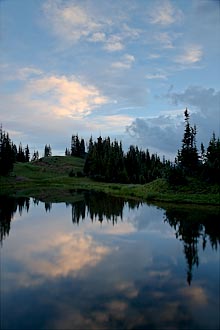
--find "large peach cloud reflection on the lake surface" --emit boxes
[7,232,111,287]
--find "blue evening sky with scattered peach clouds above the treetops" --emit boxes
[0,0,220,159]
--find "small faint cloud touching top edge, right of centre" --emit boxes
[150,1,183,26]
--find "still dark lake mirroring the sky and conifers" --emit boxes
[0,193,220,330]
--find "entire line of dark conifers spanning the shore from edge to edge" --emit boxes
[0,109,220,185]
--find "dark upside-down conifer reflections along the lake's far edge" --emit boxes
[0,190,220,285]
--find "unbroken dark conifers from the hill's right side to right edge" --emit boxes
[84,109,220,185]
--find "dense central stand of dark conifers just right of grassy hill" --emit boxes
[84,136,166,183]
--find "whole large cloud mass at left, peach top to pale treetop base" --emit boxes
[0,67,109,154]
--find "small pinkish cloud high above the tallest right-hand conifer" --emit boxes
[174,45,203,65]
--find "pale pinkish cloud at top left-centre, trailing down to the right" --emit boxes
[43,0,131,52]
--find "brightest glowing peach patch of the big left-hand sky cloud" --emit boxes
[26,76,107,117]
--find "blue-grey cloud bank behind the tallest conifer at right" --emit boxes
[127,86,220,157]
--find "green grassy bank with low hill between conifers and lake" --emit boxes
[0,156,220,205]
